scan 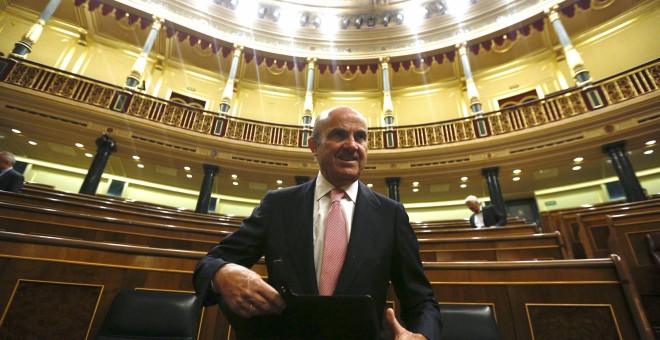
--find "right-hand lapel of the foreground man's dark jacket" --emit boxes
[335,182,382,294]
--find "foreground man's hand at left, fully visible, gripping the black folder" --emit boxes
[213,263,286,318]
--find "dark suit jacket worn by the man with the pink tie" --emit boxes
[193,180,441,339]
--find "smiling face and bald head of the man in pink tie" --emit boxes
[309,107,368,187]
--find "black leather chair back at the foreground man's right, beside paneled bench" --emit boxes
[440,303,501,340]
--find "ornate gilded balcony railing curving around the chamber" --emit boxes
[0,58,660,149]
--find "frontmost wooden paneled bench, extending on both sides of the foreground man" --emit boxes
[0,231,651,340]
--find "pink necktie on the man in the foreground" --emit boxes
[319,188,348,295]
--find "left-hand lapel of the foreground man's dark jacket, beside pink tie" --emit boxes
[283,180,318,294]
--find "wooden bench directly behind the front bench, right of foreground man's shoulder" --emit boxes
[419,232,566,261]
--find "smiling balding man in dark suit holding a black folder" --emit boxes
[193,107,442,339]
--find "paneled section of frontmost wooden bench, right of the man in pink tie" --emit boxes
[424,255,653,340]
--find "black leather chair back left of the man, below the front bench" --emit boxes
[97,290,201,340]
